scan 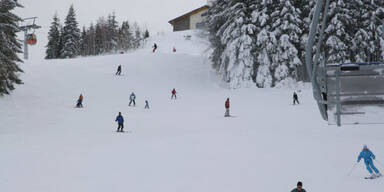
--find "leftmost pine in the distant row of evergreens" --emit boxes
[45,13,61,59]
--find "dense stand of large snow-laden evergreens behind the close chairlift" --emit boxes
[207,0,384,88]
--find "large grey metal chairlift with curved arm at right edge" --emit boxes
[305,0,384,126]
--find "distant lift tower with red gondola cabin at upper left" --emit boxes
[19,17,41,60]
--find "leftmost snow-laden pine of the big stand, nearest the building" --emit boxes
[207,0,257,88]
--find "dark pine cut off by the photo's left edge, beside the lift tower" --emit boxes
[0,0,22,95]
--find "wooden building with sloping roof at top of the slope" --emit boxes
[169,5,209,31]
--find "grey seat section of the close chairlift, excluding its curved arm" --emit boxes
[325,62,384,125]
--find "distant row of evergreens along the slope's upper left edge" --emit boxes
[46,5,149,59]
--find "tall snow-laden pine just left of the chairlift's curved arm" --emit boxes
[272,0,303,85]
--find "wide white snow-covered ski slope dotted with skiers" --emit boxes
[0,31,384,192]
